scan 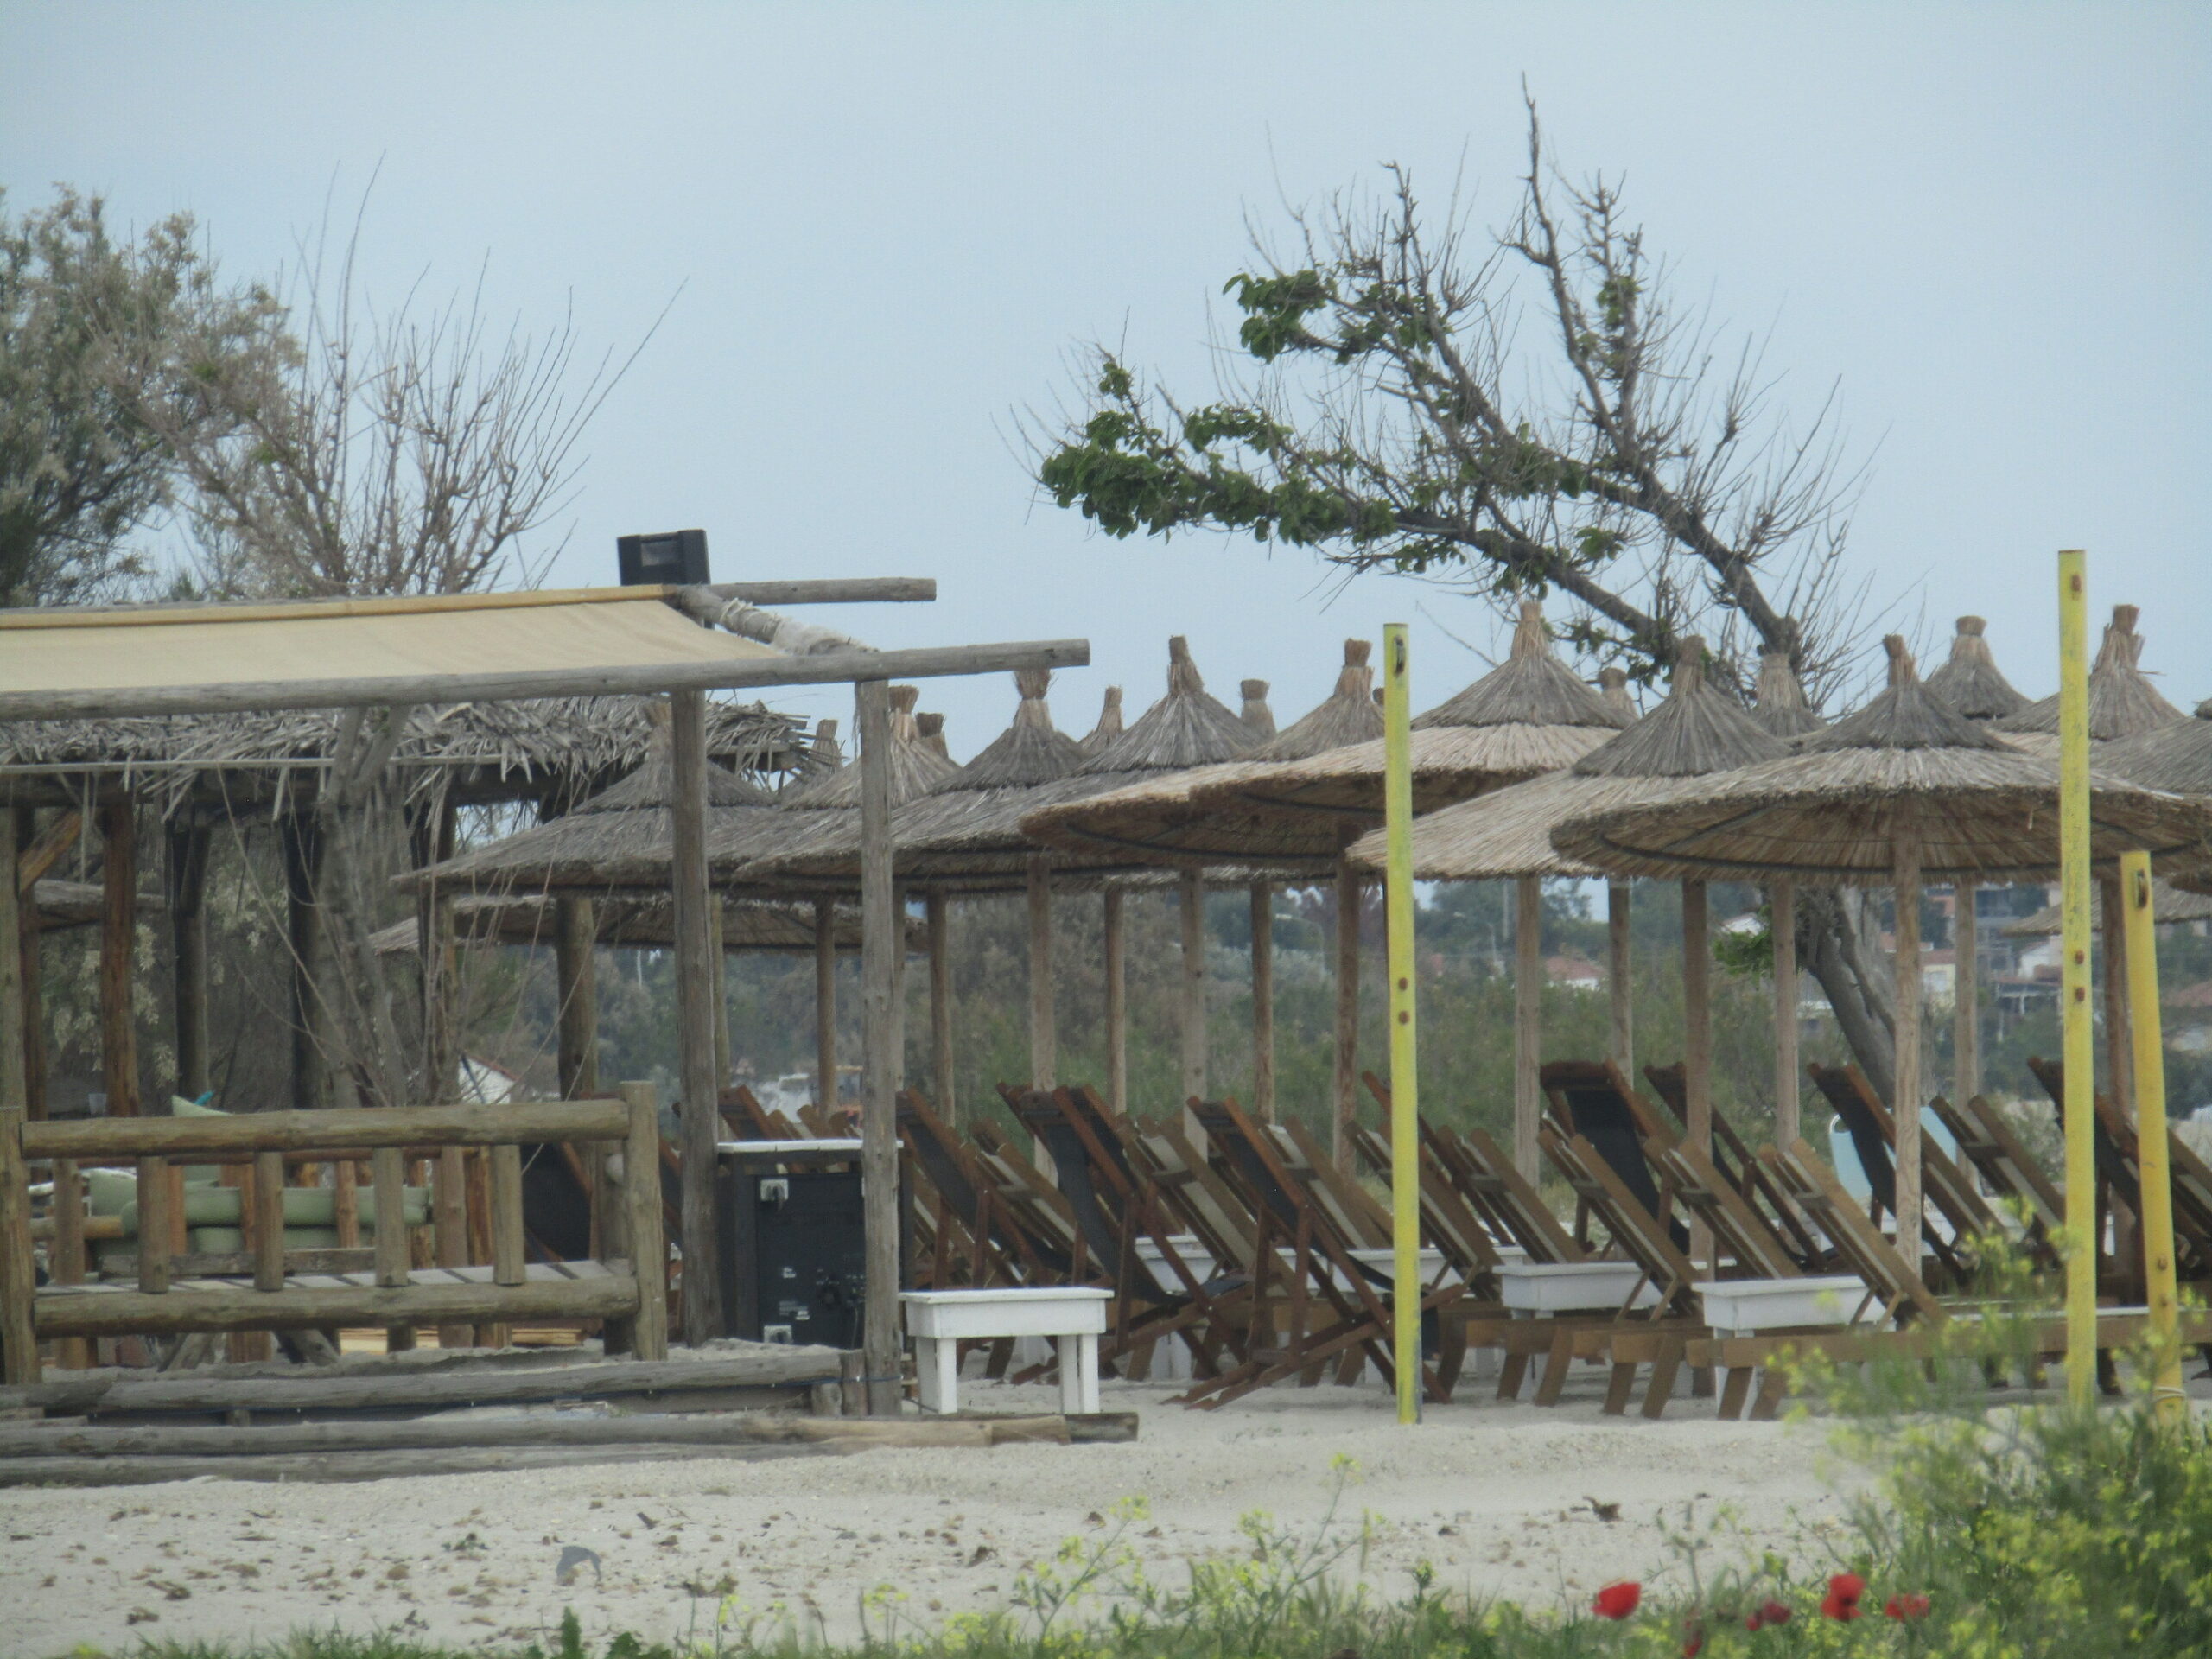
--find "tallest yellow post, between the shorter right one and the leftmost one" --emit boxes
[2059,549,2110,1407]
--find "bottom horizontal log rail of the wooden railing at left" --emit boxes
[35,1274,639,1336]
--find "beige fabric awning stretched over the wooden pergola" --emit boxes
[0,588,779,695]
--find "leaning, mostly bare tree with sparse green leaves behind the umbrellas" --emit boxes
[1024,102,1891,1092]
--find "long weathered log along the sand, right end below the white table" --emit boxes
[0,1385,1106,1460]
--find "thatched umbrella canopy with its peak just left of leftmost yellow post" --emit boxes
[1027,639,1382,874]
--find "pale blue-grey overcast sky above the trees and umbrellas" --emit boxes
[0,0,2212,754]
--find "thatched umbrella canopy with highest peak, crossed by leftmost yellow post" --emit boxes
[1210,600,1635,825]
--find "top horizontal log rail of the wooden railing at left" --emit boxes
[24,1099,631,1161]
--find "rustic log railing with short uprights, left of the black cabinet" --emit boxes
[0,1084,668,1382]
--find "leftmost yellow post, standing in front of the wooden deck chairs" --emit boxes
[1382,621,1421,1422]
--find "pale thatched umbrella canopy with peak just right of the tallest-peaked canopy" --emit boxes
[1351,637,1789,880]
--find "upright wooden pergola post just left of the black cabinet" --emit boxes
[668,690,723,1347]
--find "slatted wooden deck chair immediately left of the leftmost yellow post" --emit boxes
[1181,1099,1462,1409]
